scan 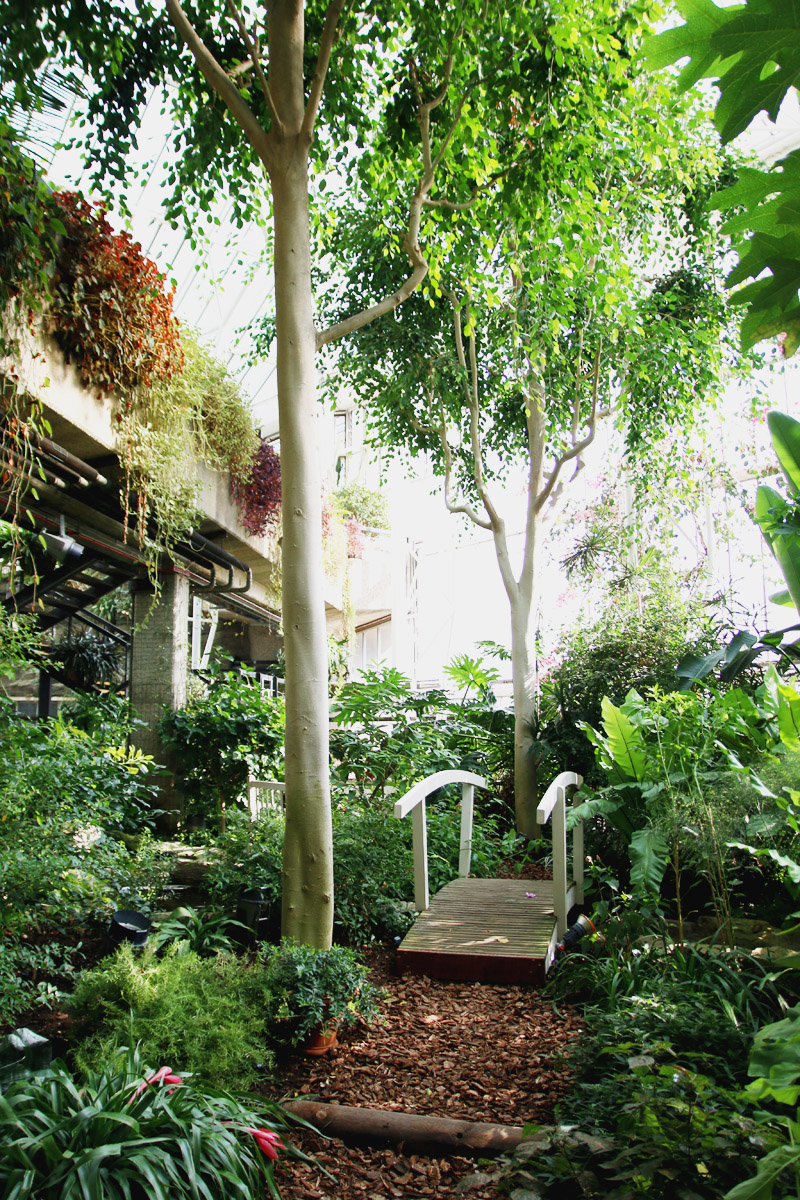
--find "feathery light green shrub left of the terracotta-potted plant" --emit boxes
[70,943,273,1091]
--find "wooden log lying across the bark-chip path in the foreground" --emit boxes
[283,1100,522,1158]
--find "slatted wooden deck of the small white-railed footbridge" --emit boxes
[397,878,554,985]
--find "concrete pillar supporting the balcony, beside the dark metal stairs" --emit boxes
[131,568,190,828]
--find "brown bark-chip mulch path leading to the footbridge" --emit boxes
[277,949,582,1200]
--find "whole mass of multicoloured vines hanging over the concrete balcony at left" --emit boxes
[0,120,262,581]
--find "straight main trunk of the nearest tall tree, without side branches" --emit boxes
[269,0,333,948]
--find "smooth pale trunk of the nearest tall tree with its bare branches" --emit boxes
[167,0,449,947]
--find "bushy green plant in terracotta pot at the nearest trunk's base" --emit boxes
[261,938,378,1045]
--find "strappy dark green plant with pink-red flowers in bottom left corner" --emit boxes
[0,1049,295,1200]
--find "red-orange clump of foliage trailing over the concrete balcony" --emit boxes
[52,192,184,396]
